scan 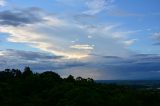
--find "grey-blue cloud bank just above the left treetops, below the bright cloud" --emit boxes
[0,49,85,72]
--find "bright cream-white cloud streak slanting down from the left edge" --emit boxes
[0,25,88,58]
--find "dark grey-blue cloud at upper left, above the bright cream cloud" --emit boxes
[0,8,42,26]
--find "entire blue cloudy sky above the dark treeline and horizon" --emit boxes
[0,0,160,80]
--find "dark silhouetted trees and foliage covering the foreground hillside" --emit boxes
[0,67,160,106]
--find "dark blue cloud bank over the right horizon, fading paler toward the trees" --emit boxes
[53,54,160,80]
